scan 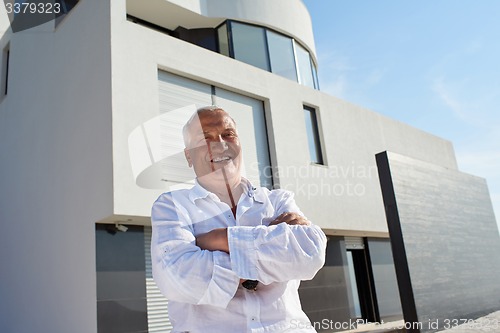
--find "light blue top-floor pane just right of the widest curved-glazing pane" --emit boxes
[267,30,297,81]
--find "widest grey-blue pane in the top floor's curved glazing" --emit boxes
[231,22,270,71]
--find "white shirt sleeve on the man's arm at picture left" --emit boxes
[151,193,239,308]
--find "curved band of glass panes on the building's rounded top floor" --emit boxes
[217,20,319,89]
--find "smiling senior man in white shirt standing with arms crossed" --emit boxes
[151,106,326,333]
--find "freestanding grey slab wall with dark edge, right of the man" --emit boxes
[377,153,500,332]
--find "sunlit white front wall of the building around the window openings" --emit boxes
[112,0,456,236]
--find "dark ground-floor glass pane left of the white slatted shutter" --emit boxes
[96,224,148,333]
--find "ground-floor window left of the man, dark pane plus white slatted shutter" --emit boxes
[96,224,172,333]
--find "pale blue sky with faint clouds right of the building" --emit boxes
[303,0,500,228]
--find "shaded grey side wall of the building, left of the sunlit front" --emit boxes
[0,0,112,333]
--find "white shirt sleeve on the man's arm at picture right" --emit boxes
[227,191,326,284]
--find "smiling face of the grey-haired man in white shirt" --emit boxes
[185,110,242,180]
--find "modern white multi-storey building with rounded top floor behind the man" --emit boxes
[0,0,496,333]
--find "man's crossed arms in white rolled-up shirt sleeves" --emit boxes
[151,191,326,308]
